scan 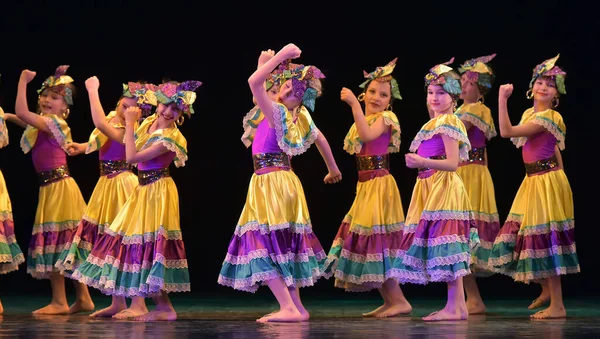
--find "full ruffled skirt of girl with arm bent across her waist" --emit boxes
[401,170,479,284]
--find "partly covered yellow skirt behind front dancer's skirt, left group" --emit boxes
[56,171,138,276]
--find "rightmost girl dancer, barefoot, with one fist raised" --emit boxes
[489,55,580,319]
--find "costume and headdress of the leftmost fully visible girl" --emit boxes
[21,66,86,279]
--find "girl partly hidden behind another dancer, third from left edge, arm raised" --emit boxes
[56,77,156,319]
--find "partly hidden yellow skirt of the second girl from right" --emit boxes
[456,163,500,277]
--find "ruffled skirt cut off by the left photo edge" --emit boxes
[0,171,25,274]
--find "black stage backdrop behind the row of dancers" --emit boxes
[0,1,600,300]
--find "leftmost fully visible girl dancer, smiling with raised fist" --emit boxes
[15,65,94,314]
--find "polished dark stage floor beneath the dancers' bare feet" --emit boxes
[0,294,600,339]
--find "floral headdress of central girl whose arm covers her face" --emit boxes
[273,60,325,111]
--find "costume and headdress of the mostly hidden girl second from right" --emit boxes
[455,54,500,276]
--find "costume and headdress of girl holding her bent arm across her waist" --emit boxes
[401,60,478,284]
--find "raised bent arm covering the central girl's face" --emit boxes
[248,44,302,127]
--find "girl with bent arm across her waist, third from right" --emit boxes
[401,59,478,321]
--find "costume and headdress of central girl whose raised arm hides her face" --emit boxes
[218,65,326,292]
